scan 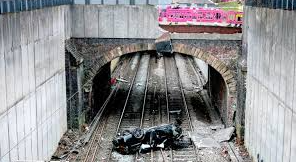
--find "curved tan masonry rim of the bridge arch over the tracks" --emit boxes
[90,43,236,94]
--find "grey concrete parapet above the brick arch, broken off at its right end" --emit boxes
[71,5,162,39]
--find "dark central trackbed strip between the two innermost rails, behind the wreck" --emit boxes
[137,55,168,162]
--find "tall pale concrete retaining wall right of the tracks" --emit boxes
[244,7,296,162]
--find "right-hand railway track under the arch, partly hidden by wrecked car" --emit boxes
[164,57,198,162]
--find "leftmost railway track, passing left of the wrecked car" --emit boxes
[78,54,140,162]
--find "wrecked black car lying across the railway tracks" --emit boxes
[112,121,182,154]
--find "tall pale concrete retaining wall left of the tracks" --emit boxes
[0,6,71,162]
